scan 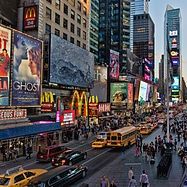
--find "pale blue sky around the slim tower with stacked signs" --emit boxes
[149,0,187,83]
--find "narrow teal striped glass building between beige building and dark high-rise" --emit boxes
[89,0,99,63]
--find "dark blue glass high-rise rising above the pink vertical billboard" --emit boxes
[99,0,130,75]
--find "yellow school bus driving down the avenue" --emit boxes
[107,126,139,147]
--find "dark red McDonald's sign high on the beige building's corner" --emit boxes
[23,6,38,30]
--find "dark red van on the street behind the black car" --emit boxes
[36,145,71,162]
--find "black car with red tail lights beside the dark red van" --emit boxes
[51,151,87,166]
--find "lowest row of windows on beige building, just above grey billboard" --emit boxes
[45,23,86,49]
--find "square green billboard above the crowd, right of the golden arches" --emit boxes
[110,83,128,103]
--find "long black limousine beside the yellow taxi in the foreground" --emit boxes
[28,165,87,187]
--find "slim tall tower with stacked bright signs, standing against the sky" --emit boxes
[164,5,182,102]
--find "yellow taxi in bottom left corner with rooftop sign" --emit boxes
[0,166,48,187]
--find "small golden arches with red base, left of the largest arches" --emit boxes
[41,92,54,112]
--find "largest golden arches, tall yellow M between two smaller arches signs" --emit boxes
[71,90,88,116]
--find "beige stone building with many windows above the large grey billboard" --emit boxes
[18,0,90,49]
